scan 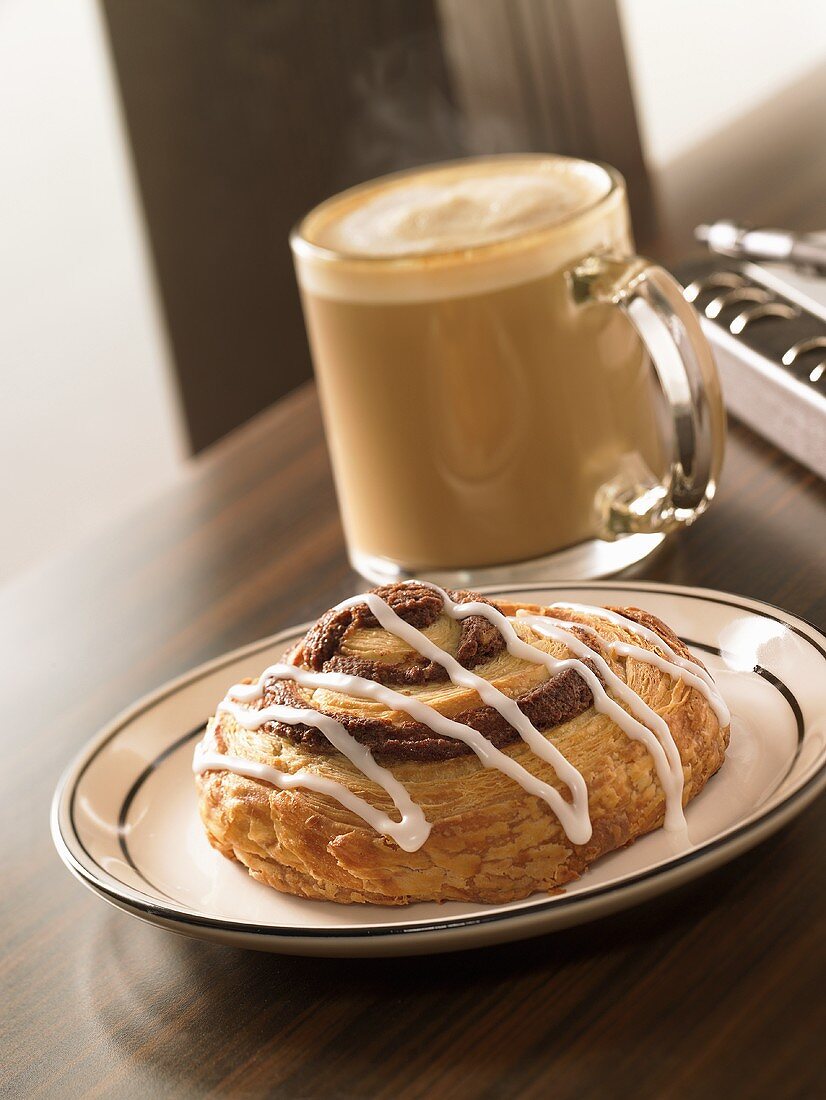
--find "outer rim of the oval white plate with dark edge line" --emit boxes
[49,579,826,946]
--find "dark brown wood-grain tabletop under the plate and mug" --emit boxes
[0,376,826,1098]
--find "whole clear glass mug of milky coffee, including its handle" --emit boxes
[290,155,725,586]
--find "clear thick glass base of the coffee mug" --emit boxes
[349,535,665,589]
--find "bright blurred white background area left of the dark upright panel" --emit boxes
[0,0,184,581]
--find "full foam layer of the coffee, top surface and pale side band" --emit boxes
[290,154,632,301]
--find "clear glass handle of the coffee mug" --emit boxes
[570,256,726,537]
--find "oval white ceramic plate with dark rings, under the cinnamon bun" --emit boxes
[52,582,826,955]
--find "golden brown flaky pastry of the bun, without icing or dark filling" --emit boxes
[196,590,728,905]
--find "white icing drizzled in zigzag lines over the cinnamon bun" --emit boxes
[192,581,728,851]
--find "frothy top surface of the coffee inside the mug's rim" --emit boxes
[307,160,608,256]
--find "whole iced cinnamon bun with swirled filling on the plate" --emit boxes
[194,582,729,905]
